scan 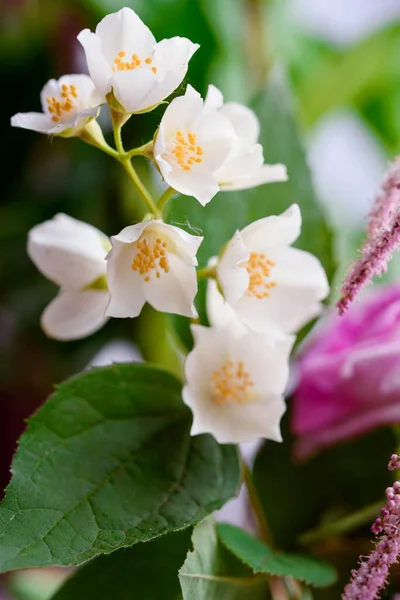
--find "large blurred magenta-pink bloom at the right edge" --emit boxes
[292,285,400,459]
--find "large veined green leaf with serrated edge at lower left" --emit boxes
[0,364,240,572]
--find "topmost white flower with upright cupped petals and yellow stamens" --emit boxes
[78,8,199,113]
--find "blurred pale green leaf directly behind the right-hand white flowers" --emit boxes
[169,76,335,279]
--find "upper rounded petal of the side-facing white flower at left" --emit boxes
[28,214,109,289]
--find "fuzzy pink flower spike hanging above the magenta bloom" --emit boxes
[337,157,400,315]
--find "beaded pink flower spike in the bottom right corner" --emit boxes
[342,454,400,600]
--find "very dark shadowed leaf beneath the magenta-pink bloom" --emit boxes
[253,414,396,552]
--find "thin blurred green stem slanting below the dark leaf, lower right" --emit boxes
[299,500,385,545]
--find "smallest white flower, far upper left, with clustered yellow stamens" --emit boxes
[11,75,101,137]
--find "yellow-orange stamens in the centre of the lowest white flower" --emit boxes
[211,360,254,404]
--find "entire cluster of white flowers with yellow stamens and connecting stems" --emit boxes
[12,8,328,443]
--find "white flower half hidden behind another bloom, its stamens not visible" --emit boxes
[204,85,288,191]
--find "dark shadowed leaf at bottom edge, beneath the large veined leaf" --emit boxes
[52,529,190,600]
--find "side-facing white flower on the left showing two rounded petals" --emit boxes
[28,214,110,340]
